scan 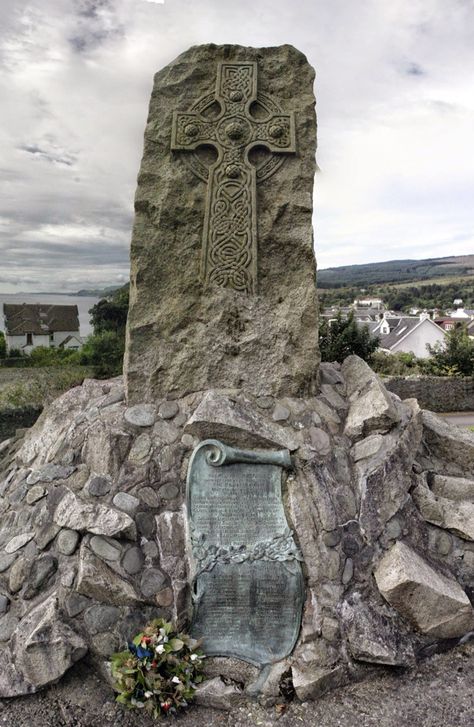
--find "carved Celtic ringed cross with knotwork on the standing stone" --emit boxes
[171,63,296,293]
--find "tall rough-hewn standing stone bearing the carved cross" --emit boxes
[125,45,319,404]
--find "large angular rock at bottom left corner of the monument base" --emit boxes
[0,593,87,697]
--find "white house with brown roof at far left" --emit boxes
[3,303,82,354]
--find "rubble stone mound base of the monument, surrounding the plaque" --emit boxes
[0,356,474,707]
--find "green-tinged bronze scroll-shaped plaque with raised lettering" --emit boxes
[187,439,304,666]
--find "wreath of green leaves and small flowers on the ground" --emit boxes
[110,619,204,718]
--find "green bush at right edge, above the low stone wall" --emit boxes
[426,324,474,376]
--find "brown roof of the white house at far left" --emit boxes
[3,303,79,336]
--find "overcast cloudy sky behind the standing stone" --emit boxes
[0,0,474,293]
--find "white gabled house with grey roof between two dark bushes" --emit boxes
[372,312,446,358]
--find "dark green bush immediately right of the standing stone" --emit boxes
[319,313,379,363]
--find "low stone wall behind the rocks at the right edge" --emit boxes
[383,376,474,412]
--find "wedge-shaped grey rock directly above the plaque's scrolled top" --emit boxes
[185,391,298,450]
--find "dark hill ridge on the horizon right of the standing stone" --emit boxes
[318,255,474,289]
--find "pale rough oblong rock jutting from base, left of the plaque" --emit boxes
[53,490,136,540]
